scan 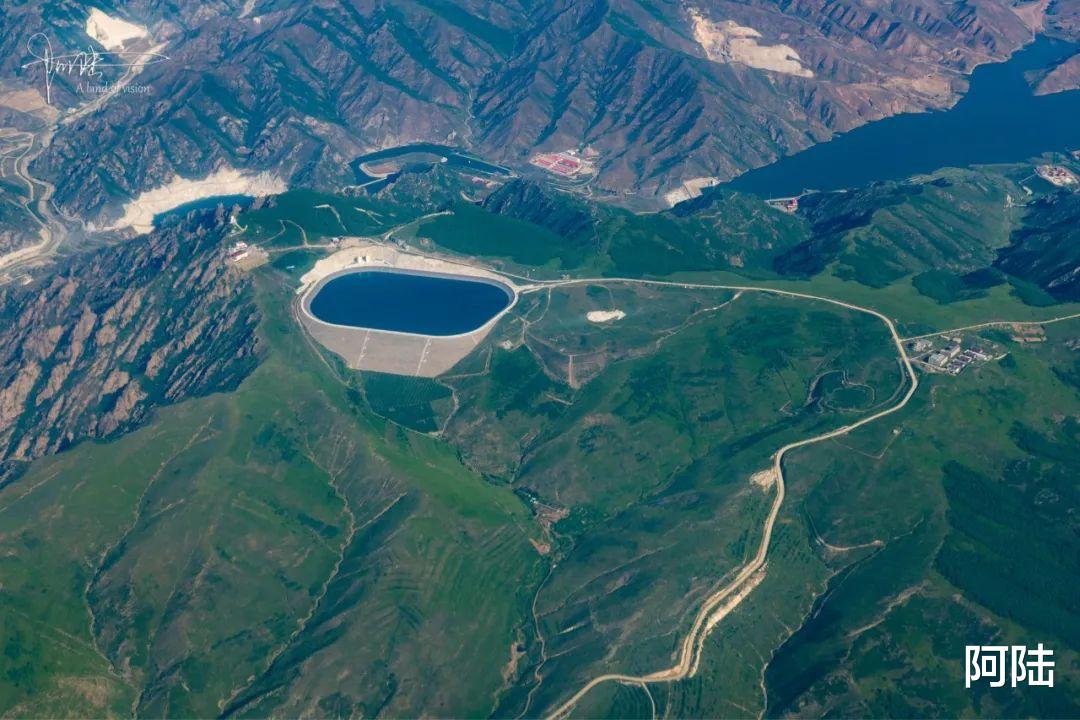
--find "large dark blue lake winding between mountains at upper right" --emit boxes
[720,38,1080,198]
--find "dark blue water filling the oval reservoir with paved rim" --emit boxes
[309,270,511,336]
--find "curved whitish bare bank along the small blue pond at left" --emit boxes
[105,167,287,232]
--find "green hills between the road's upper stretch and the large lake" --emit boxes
[396,166,1080,335]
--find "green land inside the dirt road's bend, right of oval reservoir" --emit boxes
[425,283,902,715]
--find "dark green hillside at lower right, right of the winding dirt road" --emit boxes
[609,322,1080,718]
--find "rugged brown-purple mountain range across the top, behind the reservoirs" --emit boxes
[0,0,1045,216]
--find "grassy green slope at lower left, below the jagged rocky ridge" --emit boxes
[0,277,540,717]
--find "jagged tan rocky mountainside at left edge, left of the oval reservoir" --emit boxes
[0,213,258,462]
